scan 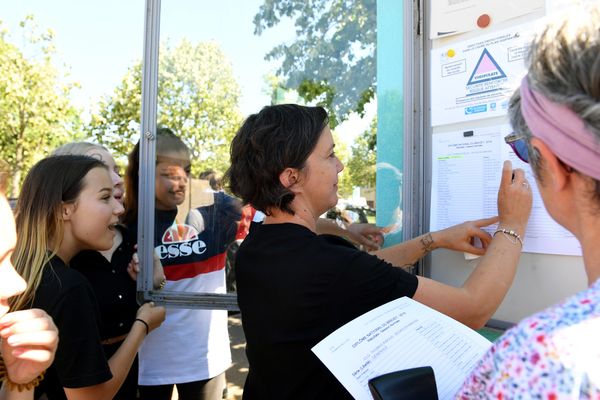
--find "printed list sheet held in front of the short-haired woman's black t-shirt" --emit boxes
[312,297,492,400]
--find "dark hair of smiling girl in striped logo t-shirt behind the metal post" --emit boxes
[123,127,190,225]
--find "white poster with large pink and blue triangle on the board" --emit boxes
[431,25,532,126]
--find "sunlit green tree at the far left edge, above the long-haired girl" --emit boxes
[0,16,81,197]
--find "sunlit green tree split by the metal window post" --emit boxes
[88,39,242,175]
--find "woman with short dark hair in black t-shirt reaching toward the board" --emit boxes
[226,104,532,399]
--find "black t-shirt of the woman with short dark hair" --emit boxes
[235,224,417,399]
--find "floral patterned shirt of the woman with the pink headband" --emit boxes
[456,279,600,400]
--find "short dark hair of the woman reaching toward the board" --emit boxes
[224,104,329,215]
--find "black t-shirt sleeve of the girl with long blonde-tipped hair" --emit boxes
[50,285,112,388]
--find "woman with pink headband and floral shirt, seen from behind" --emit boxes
[457,5,600,399]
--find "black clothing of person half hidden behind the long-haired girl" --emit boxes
[70,226,139,400]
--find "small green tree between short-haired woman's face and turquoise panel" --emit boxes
[347,118,377,188]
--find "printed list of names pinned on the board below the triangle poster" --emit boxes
[430,124,581,256]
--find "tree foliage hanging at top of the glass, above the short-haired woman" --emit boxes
[254,0,376,126]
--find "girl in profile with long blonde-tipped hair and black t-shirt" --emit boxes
[13,155,165,400]
